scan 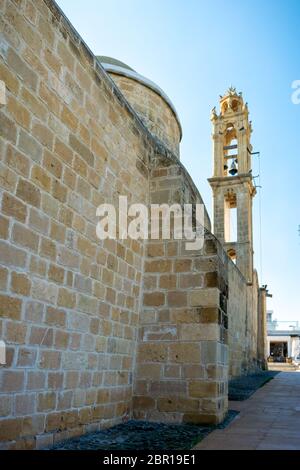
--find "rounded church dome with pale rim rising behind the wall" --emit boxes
[97,56,182,157]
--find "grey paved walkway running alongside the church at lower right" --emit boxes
[194,372,300,450]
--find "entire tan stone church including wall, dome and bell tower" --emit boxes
[0,0,267,449]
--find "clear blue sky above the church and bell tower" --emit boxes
[58,0,300,321]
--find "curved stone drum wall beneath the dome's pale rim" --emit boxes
[110,73,181,157]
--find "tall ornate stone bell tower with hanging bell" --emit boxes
[208,87,256,284]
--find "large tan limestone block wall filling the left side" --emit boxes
[0,0,152,448]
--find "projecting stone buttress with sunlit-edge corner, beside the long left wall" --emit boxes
[133,159,228,423]
